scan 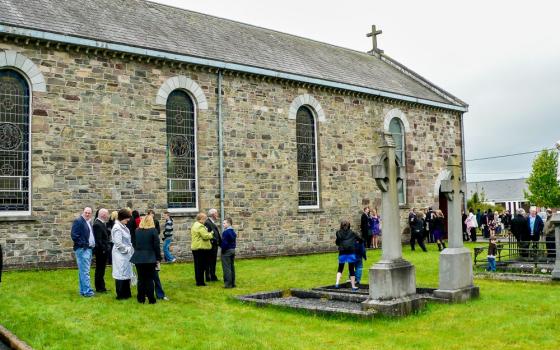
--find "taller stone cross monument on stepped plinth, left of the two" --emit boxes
[369,133,416,302]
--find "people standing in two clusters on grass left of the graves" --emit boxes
[71,207,237,304]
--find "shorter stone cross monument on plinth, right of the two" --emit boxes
[434,155,479,302]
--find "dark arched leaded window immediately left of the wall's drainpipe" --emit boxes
[165,90,198,210]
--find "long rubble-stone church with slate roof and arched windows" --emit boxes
[0,0,468,266]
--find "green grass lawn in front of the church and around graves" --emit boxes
[0,245,560,350]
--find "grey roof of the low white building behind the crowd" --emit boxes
[467,179,528,202]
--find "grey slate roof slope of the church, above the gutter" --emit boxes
[0,0,466,107]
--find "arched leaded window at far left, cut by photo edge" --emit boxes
[0,69,31,214]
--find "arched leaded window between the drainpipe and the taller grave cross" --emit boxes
[296,106,319,208]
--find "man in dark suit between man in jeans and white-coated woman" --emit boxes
[93,209,111,293]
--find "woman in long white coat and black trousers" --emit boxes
[111,209,134,300]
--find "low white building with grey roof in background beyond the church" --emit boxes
[467,178,529,213]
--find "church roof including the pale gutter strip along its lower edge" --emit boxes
[0,0,468,112]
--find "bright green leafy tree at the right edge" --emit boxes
[524,150,560,208]
